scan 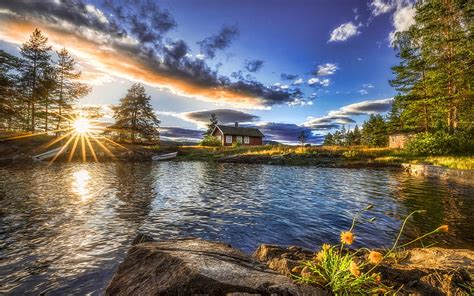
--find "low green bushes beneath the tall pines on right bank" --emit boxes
[406,131,474,155]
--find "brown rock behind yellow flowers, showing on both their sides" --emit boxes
[253,245,474,295]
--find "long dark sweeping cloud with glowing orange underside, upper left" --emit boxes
[0,0,301,108]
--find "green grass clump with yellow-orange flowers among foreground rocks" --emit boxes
[292,206,448,295]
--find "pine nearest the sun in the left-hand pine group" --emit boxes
[56,48,90,130]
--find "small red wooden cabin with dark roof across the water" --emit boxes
[211,122,264,146]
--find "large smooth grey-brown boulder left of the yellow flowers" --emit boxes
[106,239,327,295]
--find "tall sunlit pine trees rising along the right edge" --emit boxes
[388,0,474,134]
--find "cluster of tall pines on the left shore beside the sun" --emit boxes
[0,29,90,132]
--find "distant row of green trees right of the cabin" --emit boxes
[323,114,388,147]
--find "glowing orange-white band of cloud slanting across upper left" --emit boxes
[0,16,265,108]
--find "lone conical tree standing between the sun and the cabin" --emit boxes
[111,83,160,143]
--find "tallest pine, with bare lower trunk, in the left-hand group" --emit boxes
[20,29,51,132]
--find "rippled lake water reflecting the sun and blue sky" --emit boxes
[0,162,474,295]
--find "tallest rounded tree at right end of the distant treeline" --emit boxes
[362,114,388,147]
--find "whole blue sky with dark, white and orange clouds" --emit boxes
[0,0,415,144]
